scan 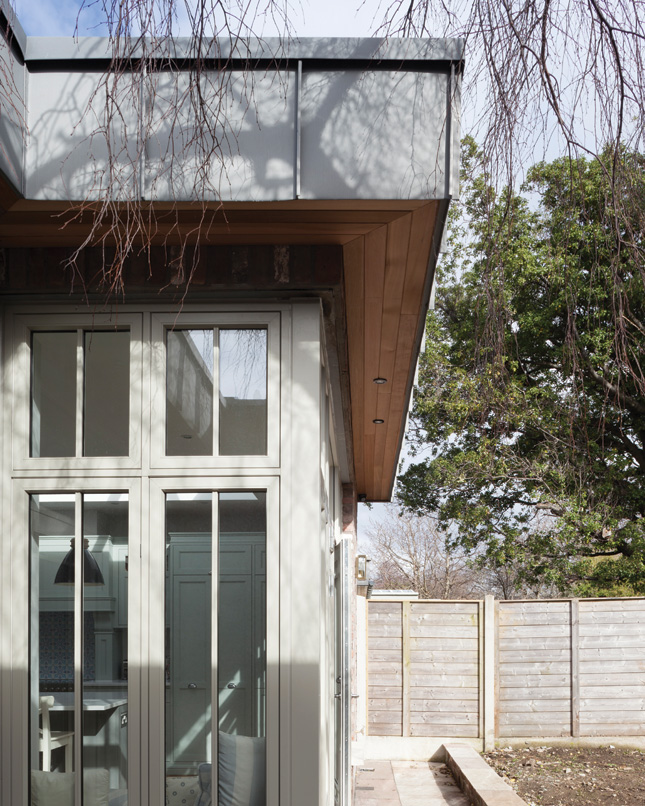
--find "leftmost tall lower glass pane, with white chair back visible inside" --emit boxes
[30,495,74,806]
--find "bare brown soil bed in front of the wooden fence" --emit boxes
[484,746,645,806]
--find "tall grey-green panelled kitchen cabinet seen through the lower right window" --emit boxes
[166,533,266,774]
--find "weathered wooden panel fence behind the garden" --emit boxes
[367,597,645,744]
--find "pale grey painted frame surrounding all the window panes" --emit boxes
[0,302,286,806]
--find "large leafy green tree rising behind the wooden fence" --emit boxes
[399,141,645,595]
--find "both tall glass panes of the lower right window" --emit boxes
[166,492,266,804]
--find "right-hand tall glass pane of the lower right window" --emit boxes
[217,492,266,803]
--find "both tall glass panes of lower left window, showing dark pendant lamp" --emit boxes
[30,493,128,806]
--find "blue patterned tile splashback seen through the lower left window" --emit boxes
[39,611,96,680]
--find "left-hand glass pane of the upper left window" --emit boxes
[31,332,77,457]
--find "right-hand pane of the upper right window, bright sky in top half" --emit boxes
[219,330,267,456]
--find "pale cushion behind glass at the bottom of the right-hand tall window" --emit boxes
[195,731,266,806]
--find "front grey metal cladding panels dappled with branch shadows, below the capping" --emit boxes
[20,40,449,207]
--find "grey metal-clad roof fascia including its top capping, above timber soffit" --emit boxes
[0,24,461,207]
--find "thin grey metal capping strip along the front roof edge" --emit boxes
[20,33,464,64]
